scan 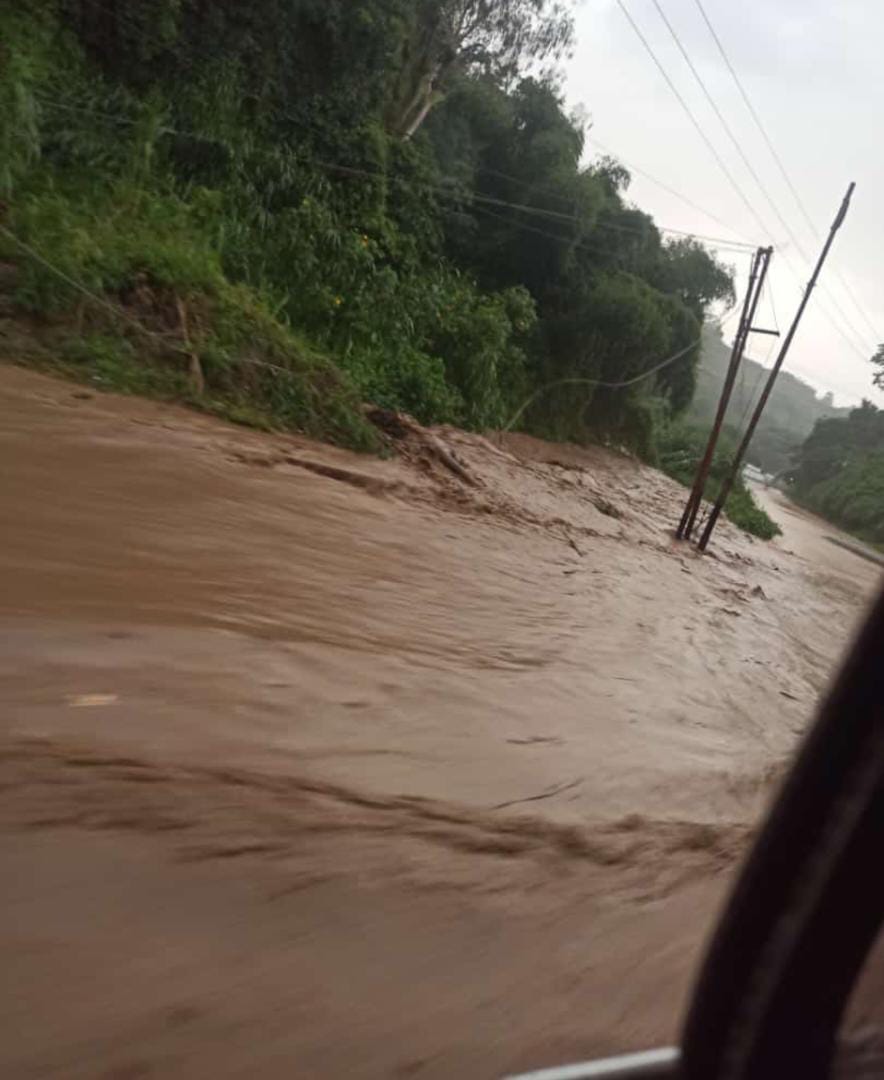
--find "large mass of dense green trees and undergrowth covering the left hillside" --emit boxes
[0,0,733,459]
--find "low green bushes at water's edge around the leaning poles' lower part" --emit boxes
[659,422,783,540]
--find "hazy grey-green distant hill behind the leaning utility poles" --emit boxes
[686,324,851,473]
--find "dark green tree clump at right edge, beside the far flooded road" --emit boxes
[789,401,884,544]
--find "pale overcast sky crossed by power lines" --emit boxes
[565,0,884,407]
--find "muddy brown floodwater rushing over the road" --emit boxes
[0,367,880,1080]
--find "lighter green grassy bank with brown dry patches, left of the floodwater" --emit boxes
[0,175,377,449]
